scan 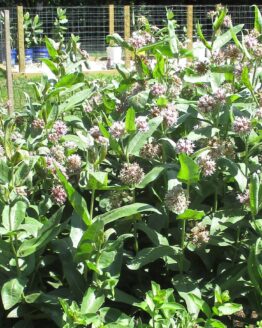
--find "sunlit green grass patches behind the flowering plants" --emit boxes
[0,72,118,110]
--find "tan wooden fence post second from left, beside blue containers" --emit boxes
[17,6,25,73]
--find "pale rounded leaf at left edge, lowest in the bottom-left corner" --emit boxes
[1,278,26,310]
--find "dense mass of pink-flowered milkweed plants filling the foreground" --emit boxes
[0,7,262,328]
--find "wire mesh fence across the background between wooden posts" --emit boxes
[0,5,262,59]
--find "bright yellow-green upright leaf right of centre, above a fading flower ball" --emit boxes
[177,153,200,184]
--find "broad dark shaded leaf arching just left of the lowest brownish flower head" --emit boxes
[127,245,179,270]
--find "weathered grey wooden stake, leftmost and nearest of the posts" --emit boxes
[4,10,14,114]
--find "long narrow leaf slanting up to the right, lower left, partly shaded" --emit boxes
[17,207,64,257]
